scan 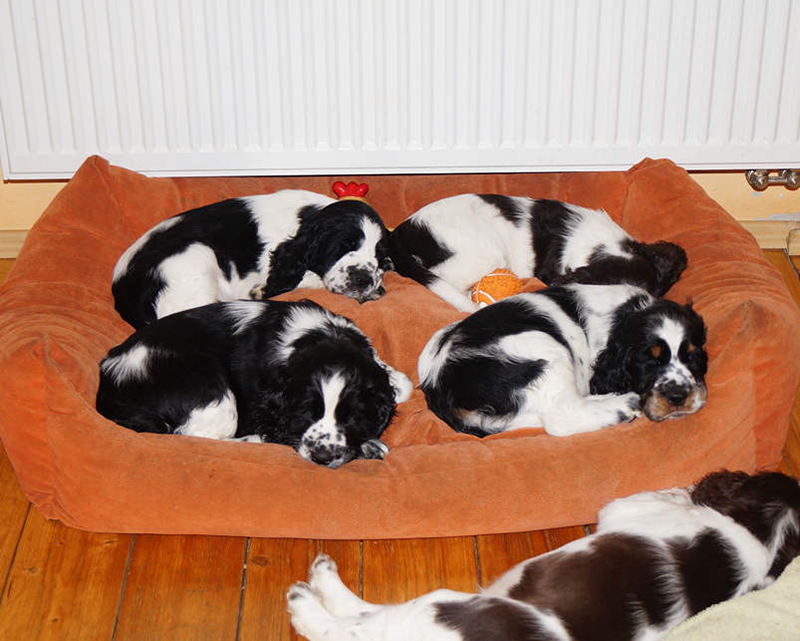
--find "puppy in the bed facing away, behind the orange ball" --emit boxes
[390,194,686,312]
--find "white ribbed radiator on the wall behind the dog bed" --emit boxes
[0,0,800,179]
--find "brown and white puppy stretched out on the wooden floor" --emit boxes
[288,472,800,641]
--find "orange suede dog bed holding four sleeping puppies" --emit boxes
[0,157,800,539]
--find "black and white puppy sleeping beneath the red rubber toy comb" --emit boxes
[111,189,392,328]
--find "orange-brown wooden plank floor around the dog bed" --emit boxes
[0,251,800,641]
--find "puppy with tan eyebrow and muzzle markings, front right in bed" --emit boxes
[418,283,708,436]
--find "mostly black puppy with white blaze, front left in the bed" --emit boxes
[97,301,413,467]
